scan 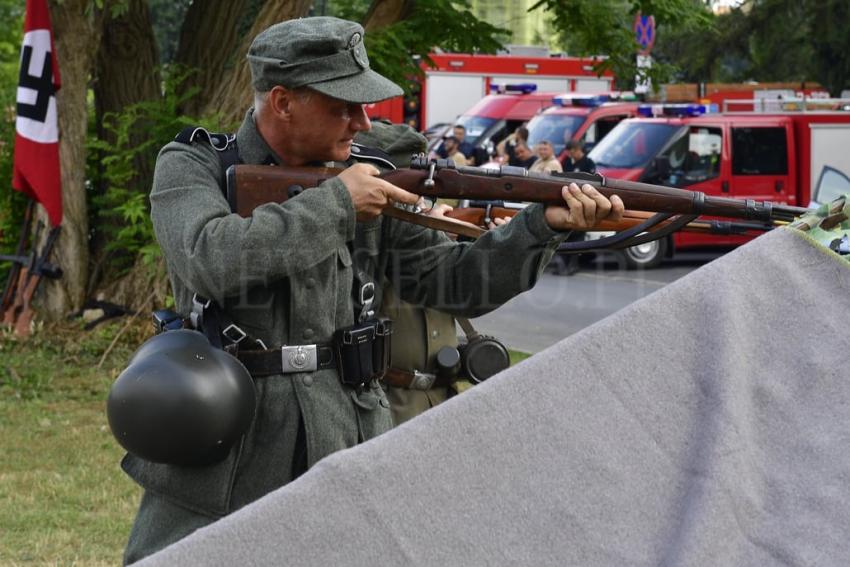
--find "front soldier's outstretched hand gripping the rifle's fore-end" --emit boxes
[545,183,625,230]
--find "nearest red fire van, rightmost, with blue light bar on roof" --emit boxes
[590,101,850,267]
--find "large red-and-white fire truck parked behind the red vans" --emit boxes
[367,53,614,130]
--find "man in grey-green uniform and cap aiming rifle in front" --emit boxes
[122,18,623,562]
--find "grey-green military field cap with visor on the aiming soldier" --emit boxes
[248,17,403,103]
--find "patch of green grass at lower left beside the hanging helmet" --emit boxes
[0,320,529,565]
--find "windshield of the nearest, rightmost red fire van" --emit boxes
[589,121,681,169]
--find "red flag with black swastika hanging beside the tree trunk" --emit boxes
[12,0,62,226]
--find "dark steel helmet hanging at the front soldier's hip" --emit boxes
[106,329,256,465]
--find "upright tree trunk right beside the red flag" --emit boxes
[42,0,108,317]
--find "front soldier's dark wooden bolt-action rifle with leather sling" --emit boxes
[227,156,808,252]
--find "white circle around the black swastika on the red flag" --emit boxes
[15,30,59,144]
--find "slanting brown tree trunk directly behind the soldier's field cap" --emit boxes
[192,0,312,129]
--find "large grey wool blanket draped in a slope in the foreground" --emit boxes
[140,229,850,566]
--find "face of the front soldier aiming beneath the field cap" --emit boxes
[291,91,372,161]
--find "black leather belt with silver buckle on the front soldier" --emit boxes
[236,345,337,376]
